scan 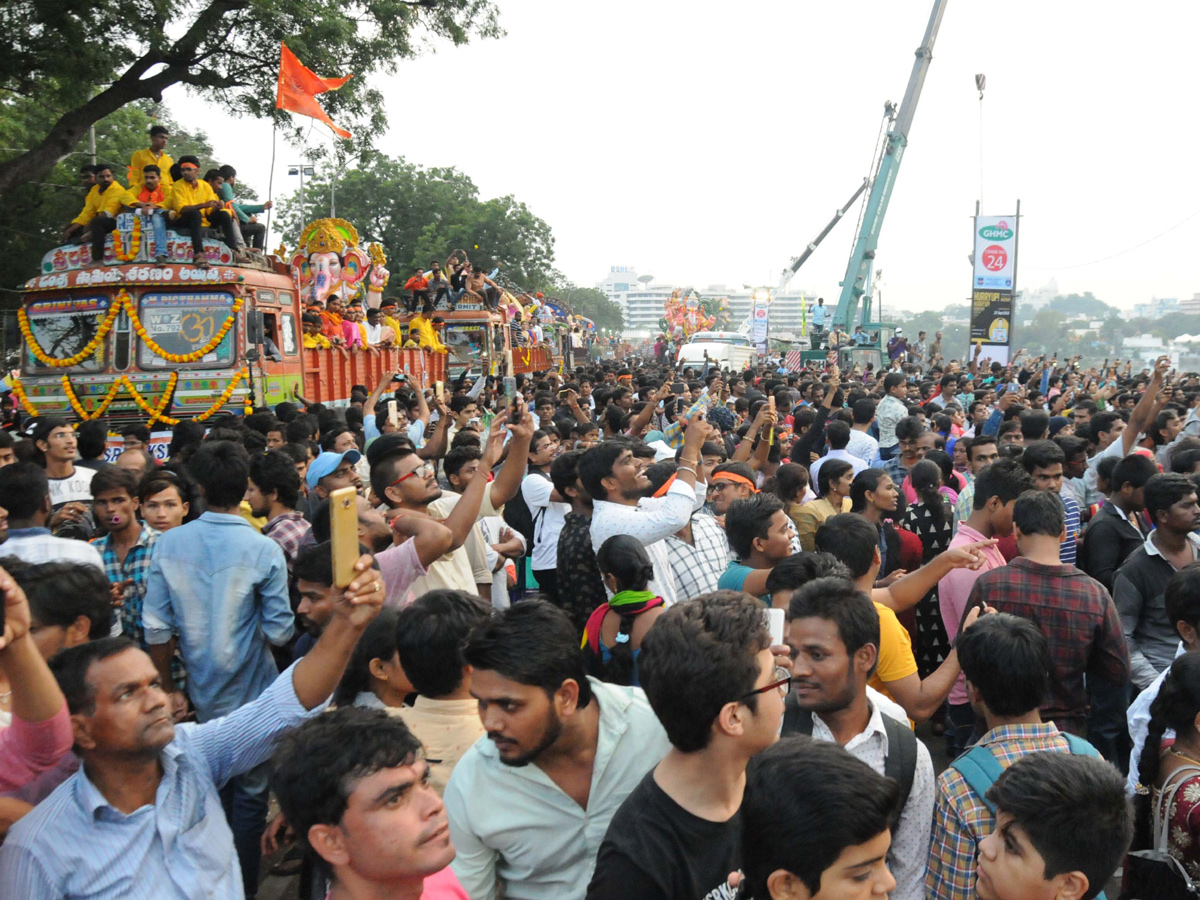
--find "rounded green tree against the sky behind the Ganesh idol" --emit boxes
[280,152,557,292]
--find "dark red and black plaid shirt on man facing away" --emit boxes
[966,557,1129,737]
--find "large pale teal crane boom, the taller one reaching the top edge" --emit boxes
[833,0,946,330]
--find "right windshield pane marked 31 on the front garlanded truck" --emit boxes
[138,290,238,370]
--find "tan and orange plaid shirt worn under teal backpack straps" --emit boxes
[925,722,1070,900]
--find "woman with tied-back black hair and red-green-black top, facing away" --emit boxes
[583,534,666,686]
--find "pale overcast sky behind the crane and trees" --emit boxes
[166,0,1200,310]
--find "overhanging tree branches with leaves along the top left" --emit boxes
[0,0,503,199]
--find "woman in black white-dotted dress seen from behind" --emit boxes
[901,452,954,678]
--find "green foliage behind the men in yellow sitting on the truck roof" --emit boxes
[0,97,216,296]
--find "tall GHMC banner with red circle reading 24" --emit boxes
[967,216,1016,364]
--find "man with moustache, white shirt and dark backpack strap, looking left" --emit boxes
[777,577,936,900]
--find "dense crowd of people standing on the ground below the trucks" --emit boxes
[0,324,1200,900]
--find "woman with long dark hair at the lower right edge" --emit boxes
[1132,653,1200,882]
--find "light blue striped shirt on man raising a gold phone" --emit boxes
[0,668,321,900]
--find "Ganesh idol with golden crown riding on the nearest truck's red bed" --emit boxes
[292,218,388,310]
